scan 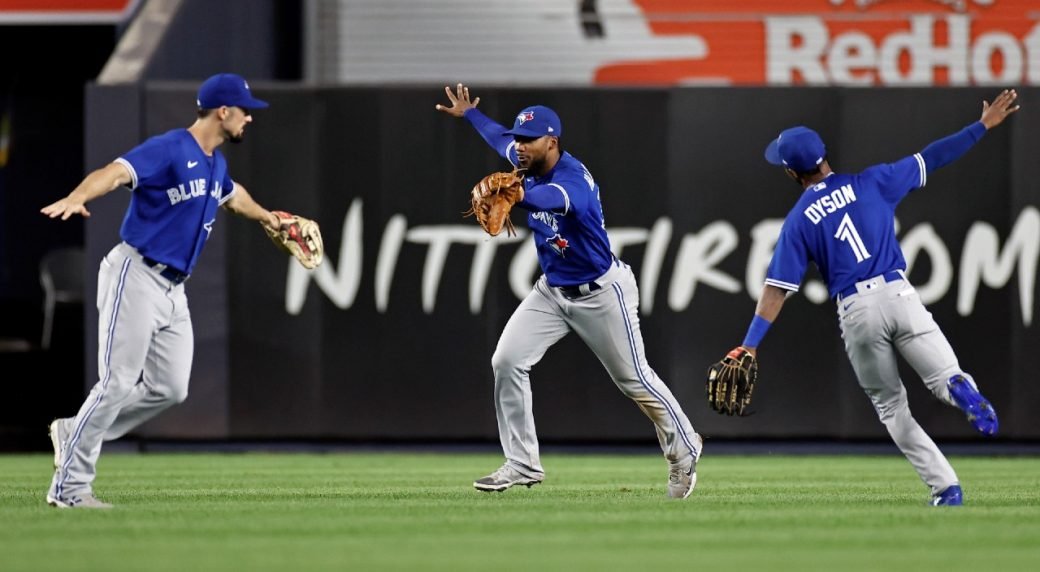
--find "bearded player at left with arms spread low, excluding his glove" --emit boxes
[42,74,293,509]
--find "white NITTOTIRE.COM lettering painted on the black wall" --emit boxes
[285,199,1040,326]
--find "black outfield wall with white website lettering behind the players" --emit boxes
[86,83,1040,442]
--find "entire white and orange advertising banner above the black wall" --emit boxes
[318,0,1040,87]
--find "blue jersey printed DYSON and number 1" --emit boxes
[765,153,928,297]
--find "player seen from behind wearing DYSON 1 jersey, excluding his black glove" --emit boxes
[743,89,1018,505]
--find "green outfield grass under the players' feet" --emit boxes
[0,452,1040,572]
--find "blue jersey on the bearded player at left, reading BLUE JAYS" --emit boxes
[115,129,235,274]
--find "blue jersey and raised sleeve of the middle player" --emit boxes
[465,109,615,287]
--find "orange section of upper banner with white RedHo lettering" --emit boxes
[595,0,1040,86]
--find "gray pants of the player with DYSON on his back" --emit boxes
[838,279,974,494]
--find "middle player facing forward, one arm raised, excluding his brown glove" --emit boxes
[436,83,702,498]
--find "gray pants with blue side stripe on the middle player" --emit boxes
[492,261,700,478]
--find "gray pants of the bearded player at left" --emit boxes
[50,242,194,499]
